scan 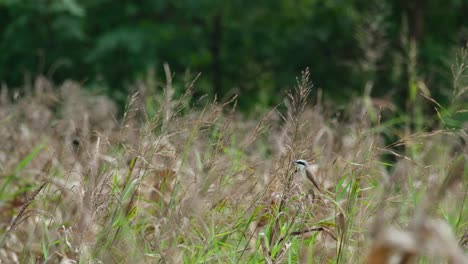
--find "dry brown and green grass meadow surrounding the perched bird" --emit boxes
[0,62,468,263]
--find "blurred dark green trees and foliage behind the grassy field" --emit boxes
[0,0,468,109]
